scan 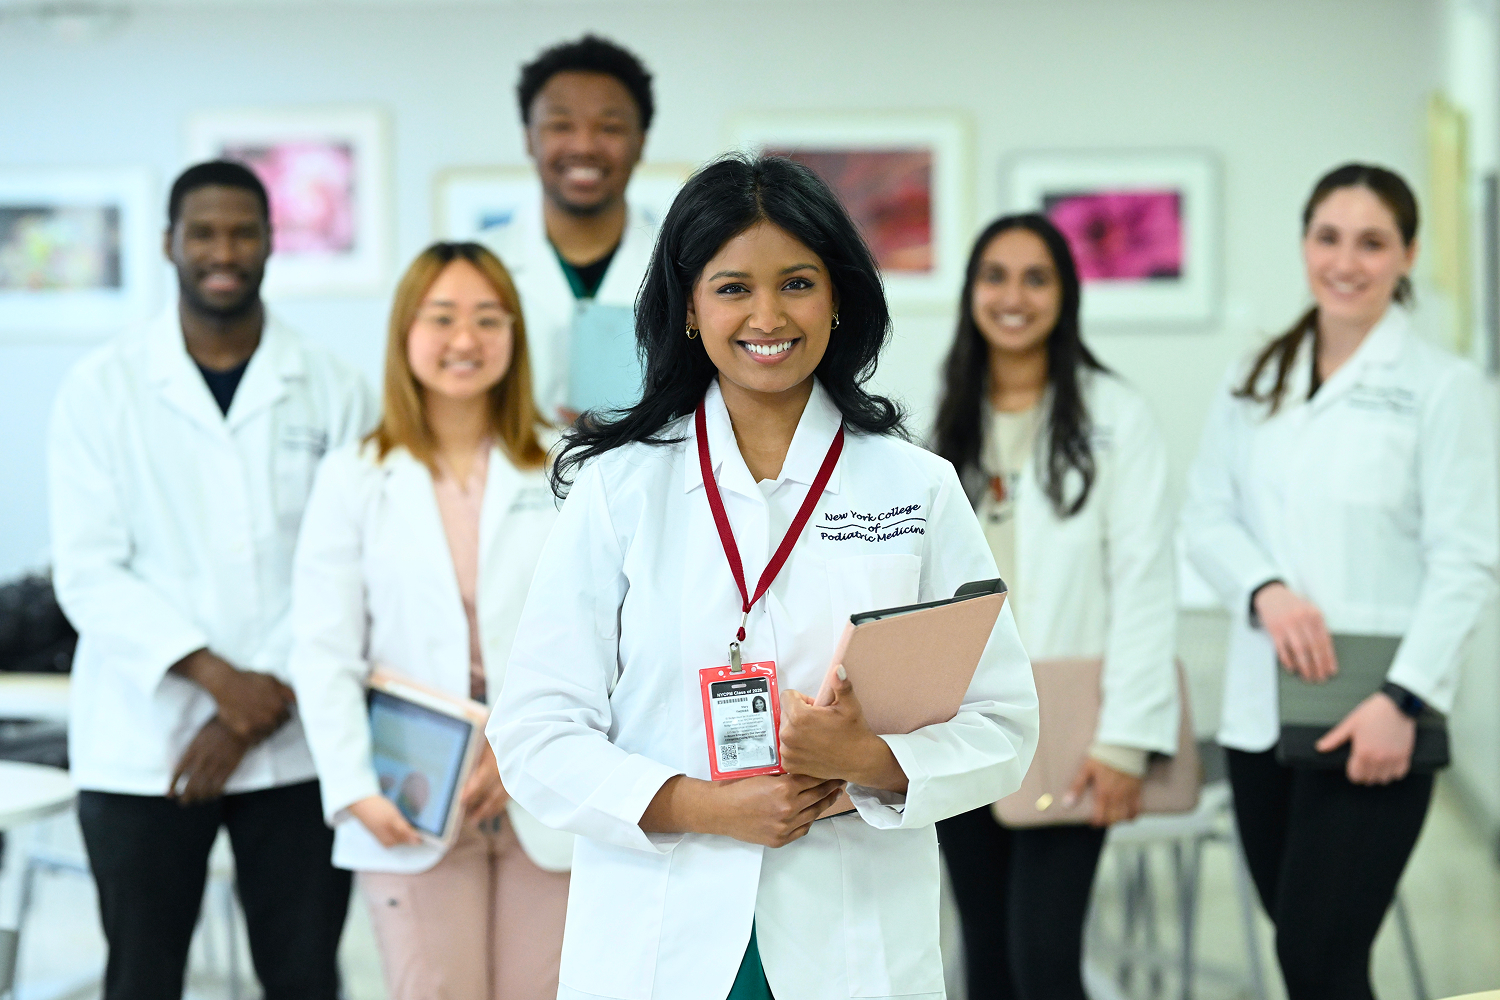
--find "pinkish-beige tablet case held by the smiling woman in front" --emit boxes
[818,591,1005,819]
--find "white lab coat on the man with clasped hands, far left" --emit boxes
[48,307,375,795]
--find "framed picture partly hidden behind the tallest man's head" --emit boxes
[432,163,693,240]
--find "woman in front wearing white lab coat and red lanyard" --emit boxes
[489,157,1037,1000]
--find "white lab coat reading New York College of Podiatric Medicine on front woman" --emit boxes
[489,384,1037,1000]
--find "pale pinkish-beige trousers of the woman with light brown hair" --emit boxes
[360,820,569,1000]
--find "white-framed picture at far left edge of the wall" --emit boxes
[0,168,165,337]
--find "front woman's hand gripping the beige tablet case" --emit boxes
[782,666,906,795]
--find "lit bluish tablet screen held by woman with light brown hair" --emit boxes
[371,691,474,837]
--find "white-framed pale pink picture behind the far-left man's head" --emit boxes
[188,108,392,297]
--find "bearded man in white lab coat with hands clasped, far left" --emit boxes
[48,162,374,1000]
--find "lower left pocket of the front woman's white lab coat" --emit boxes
[561,837,672,1000]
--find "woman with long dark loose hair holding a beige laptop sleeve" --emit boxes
[936,214,1179,1000]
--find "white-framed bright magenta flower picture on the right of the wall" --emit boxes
[1007,151,1220,325]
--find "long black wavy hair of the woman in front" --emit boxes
[552,153,906,496]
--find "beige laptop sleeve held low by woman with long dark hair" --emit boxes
[992,660,1203,828]
